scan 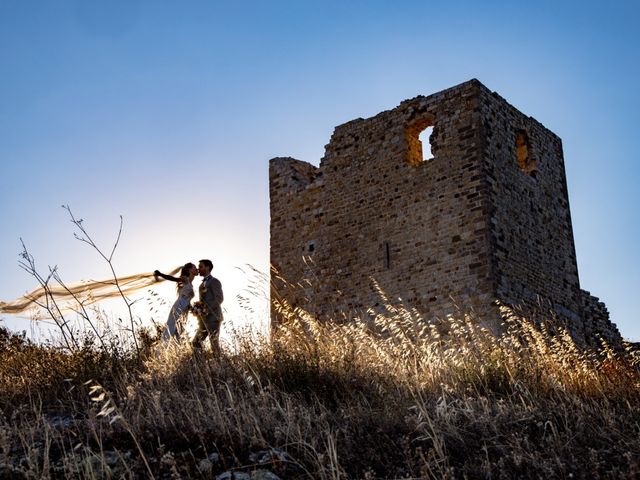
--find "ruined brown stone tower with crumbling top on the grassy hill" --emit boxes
[269,80,620,341]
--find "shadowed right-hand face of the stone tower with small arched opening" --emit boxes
[481,89,580,308]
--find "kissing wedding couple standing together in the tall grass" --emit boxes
[153,259,224,353]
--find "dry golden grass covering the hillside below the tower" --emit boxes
[0,308,640,479]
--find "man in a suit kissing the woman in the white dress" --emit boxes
[191,260,224,354]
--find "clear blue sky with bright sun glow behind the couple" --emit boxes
[0,0,640,340]
